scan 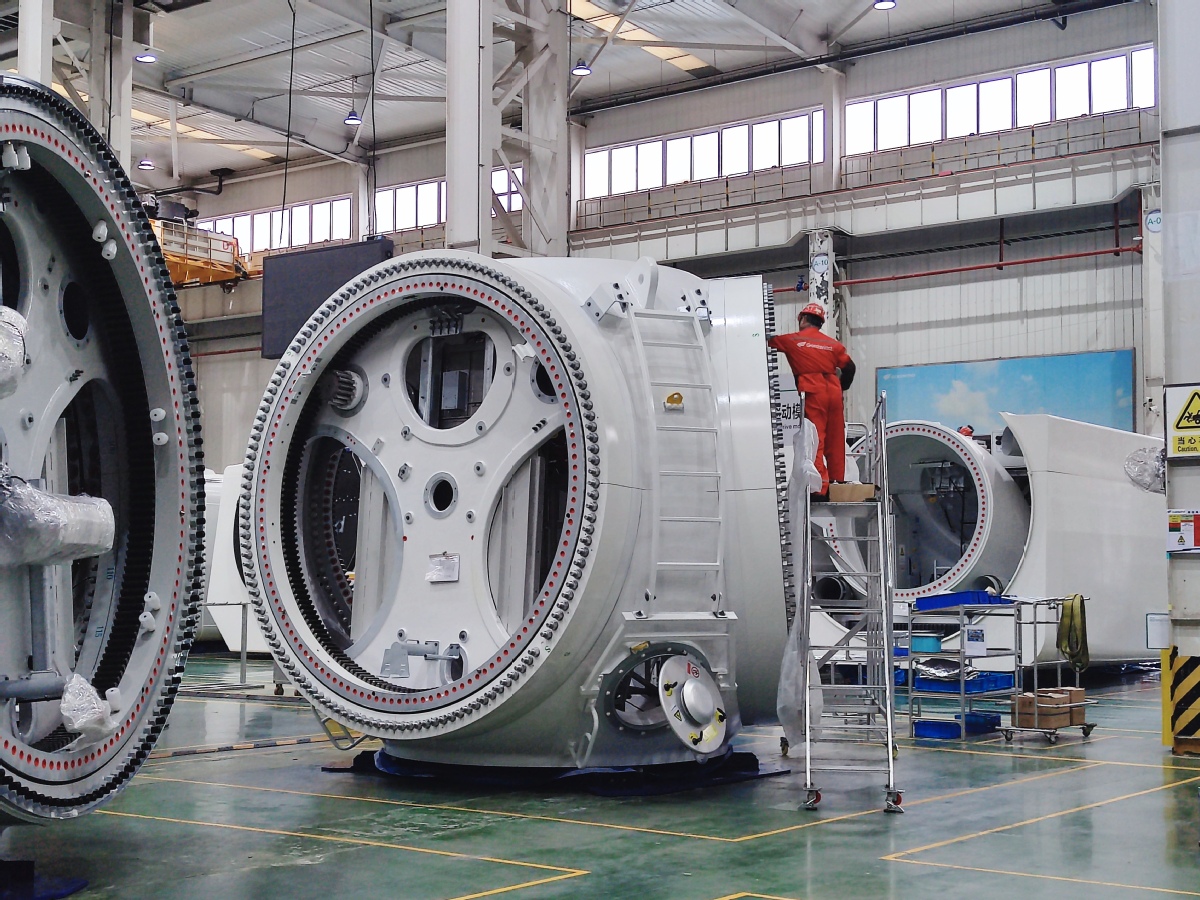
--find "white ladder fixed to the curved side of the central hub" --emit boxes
[629,307,725,612]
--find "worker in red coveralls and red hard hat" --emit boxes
[767,304,854,494]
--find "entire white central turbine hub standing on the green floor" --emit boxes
[242,252,786,767]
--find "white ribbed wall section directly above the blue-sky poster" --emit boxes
[847,233,1142,434]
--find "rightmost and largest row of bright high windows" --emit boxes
[846,48,1157,156]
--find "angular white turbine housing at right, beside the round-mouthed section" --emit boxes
[1003,413,1166,662]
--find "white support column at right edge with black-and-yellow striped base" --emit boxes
[1158,0,1200,752]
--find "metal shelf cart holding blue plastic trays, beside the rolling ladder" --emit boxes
[902,600,1018,739]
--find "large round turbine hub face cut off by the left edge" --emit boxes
[0,76,203,826]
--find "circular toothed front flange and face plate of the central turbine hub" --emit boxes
[240,253,601,739]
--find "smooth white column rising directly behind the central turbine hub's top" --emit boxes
[446,2,499,256]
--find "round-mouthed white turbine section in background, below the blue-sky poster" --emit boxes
[887,422,1032,600]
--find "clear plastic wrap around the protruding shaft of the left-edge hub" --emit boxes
[0,464,115,565]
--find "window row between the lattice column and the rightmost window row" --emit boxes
[583,109,824,199]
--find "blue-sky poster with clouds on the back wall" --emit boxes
[875,350,1134,434]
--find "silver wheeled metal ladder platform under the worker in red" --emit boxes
[794,392,904,812]
